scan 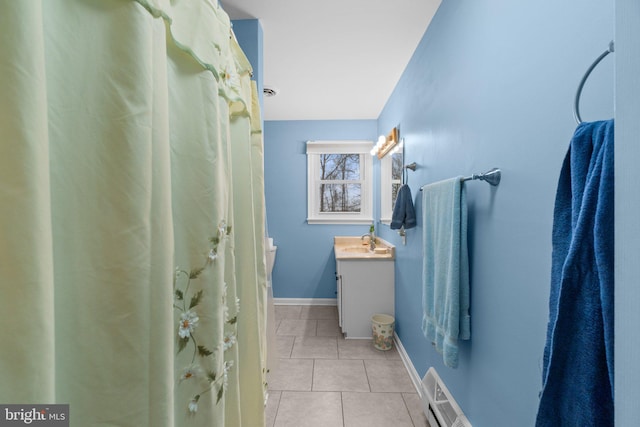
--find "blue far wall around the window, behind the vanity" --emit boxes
[264,120,377,298]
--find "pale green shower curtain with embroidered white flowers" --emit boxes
[0,0,266,427]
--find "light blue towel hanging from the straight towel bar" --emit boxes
[422,177,471,368]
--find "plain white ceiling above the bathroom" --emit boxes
[220,0,441,120]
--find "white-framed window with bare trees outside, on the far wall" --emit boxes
[307,141,373,224]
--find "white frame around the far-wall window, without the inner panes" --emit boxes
[307,141,373,224]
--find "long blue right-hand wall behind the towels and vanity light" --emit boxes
[378,0,614,427]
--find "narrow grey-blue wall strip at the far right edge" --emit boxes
[615,0,640,427]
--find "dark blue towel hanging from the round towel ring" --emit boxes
[536,120,614,427]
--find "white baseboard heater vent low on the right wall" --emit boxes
[422,367,471,427]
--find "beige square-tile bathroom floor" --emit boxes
[266,306,428,427]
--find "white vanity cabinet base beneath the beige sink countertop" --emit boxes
[336,258,395,338]
